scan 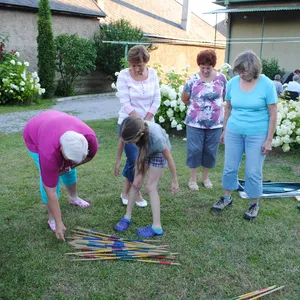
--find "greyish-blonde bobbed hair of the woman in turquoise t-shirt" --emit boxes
[233,51,262,80]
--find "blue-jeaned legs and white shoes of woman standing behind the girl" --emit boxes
[121,144,147,207]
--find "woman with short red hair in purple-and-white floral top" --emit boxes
[181,50,226,190]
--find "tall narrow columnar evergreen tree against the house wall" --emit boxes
[37,0,55,97]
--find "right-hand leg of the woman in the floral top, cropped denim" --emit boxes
[202,128,222,188]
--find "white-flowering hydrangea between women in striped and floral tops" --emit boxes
[154,65,190,131]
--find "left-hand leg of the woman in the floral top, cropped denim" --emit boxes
[186,126,204,190]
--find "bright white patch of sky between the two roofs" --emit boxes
[177,0,225,26]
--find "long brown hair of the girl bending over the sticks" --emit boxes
[120,117,149,175]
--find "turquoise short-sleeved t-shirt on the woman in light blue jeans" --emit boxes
[225,74,278,135]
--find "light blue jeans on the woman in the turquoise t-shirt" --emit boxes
[222,130,267,199]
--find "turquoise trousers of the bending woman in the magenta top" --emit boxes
[28,150,77,204]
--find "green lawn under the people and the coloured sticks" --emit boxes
[0,119,300,300]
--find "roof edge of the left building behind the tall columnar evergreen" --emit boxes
[0,0,105,17]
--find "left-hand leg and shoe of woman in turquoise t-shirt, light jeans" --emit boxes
[212,131,244,211]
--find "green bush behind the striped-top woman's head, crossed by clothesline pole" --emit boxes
[94,19,147,80]
